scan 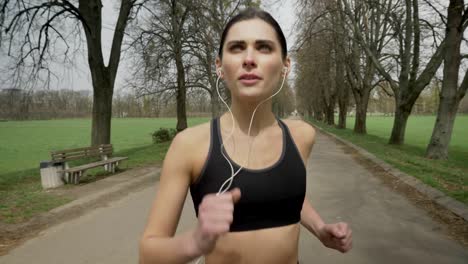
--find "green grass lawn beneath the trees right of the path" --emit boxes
[312,115,468,204]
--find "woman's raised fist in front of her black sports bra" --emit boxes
[194,188,241,255]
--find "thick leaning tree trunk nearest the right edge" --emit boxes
[426,0,466,159]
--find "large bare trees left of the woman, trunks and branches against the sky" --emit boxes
[0,0,260,145]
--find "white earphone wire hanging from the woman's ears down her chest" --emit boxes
[196,68,286,264]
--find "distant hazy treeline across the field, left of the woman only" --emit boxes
[0,88,238,120]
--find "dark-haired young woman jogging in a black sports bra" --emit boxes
[140,9,352,264]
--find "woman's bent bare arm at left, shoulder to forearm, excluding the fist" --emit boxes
[140,131,201,264]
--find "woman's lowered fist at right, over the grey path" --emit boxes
[318,222,353,253]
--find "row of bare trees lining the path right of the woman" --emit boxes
[296,0,468,159]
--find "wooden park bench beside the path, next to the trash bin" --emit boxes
[50,144,128,184]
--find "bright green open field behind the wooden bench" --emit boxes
[0,118,207,177]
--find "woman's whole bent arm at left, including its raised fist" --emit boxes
[140,125,241,264]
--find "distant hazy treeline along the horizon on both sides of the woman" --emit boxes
[4,80,458,120]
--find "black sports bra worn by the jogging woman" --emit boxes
[190,118,306,232]
